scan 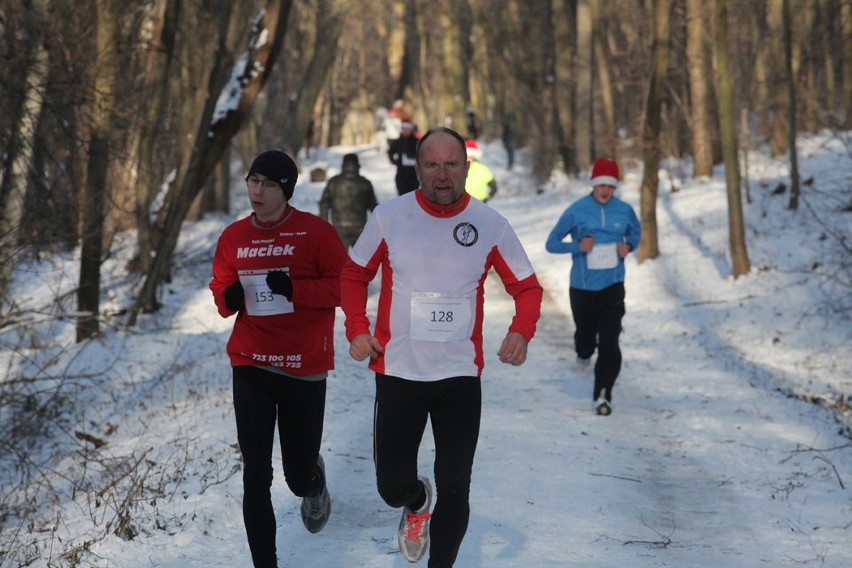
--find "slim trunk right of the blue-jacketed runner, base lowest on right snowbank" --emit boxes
[714,0,751,278]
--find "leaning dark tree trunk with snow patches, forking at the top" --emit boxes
[128,0,292,325]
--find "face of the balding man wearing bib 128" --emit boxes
[414,132,469,205]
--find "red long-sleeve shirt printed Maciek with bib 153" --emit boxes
[210,206,346,376]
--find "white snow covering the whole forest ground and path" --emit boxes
[0,133,852,568]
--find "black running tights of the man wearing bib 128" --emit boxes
[373,374,482,568]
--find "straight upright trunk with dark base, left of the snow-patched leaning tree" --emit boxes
[77,0,118,342]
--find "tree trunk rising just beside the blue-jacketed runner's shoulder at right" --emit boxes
[637,0,672,262]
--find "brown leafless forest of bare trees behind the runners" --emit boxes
[0,0,852,330]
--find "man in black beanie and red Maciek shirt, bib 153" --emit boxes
[210,150,346,567]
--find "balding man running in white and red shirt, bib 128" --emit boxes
[341,128,542,568]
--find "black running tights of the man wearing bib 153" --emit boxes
[234,367,326,568]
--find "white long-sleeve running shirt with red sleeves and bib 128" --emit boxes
[341,190,542,381]
